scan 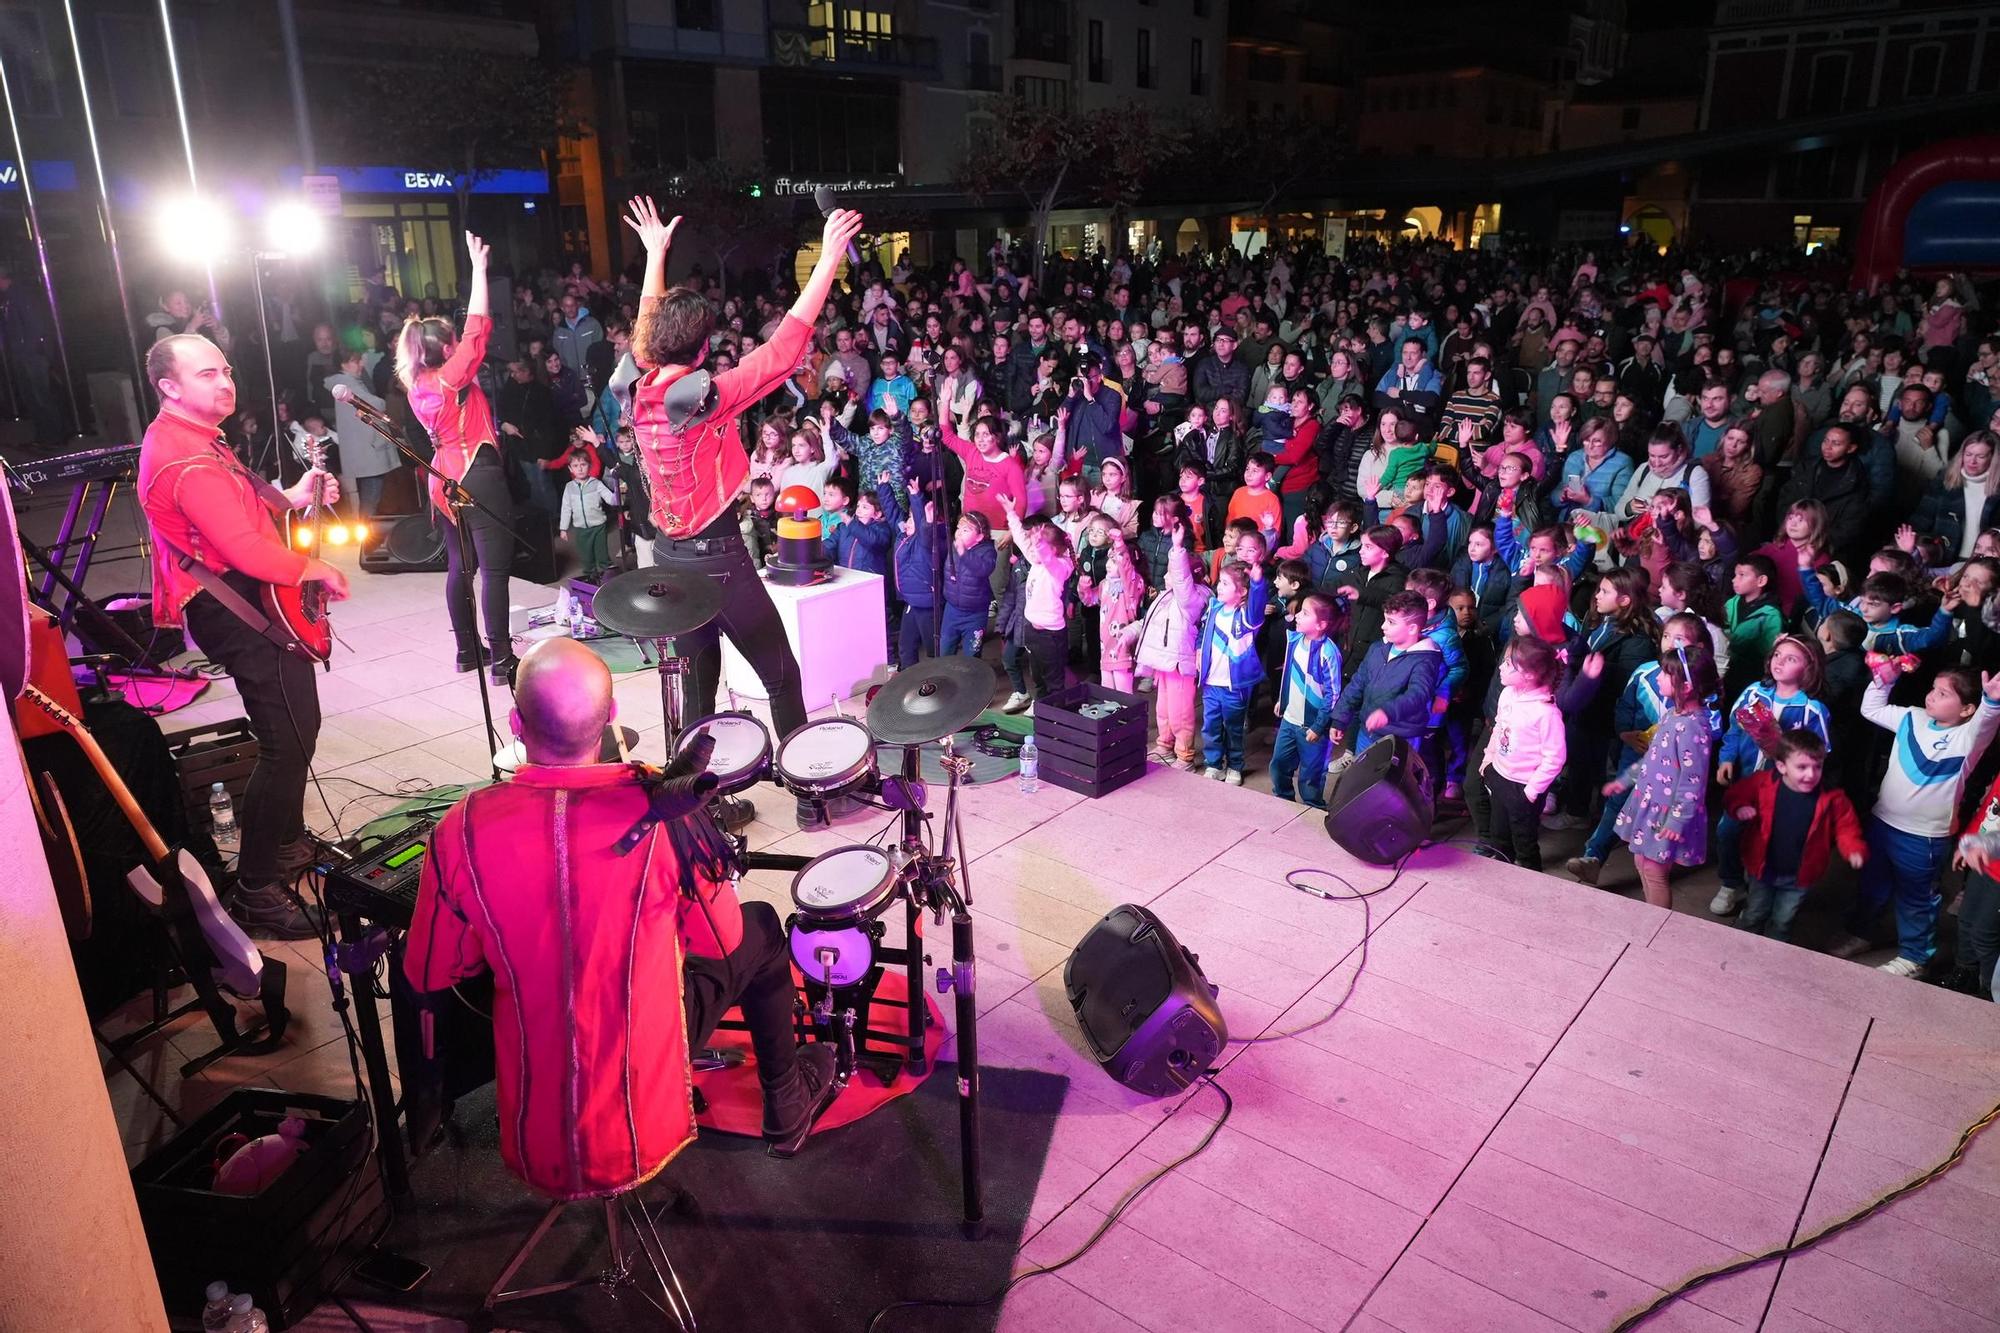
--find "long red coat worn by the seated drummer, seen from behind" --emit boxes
[402,765,742,1199]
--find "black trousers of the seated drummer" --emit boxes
[682,903,804,1129]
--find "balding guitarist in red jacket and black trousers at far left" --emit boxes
[138,334,348,939]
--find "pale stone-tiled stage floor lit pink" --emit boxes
[110,556,2000,1333]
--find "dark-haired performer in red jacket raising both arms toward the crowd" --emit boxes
[626,198,862,752]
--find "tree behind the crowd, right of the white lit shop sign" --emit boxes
[960,96,1186,284]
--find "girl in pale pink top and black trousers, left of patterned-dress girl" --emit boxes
[1480,634,1568,871]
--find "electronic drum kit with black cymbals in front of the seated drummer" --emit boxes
[594,566,994,1233]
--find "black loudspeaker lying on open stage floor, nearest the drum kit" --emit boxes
[1062,903,1230,1097]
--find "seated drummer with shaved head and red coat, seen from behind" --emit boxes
[404,638,840,1176]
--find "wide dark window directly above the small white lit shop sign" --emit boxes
[762,70,902,178]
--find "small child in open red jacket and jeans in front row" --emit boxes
[1722,731,1868,939]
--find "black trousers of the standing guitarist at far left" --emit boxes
[186,574,320,887]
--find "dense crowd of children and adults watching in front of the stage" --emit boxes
[168,228,2000,995]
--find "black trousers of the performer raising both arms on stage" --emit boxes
[652,510,806,739]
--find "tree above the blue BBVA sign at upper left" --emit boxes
[338,50,590,239]
